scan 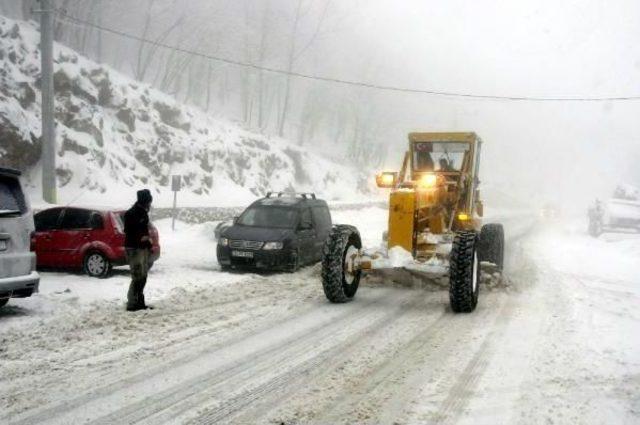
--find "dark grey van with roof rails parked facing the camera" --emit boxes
[217,193,331,271]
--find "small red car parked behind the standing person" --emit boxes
[32,207,160,277]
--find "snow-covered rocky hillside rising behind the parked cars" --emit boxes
[0,17,370,206]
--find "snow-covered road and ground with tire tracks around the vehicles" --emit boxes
[0,208,640,424]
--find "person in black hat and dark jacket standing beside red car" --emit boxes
[124,189,153,311]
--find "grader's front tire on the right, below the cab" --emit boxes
[449,232,480,313]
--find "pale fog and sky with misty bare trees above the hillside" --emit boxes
[0,0,640,209]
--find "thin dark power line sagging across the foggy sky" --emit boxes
[54,9,640,102]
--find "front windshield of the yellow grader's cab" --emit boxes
[413,142,471,172]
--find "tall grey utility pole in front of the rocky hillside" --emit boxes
[39,0,57,204]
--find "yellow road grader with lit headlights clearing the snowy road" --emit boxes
[322,132,504,312]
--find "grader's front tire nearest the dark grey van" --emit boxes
[322,225,362,303]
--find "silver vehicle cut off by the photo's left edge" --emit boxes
[0,168,40,307]
